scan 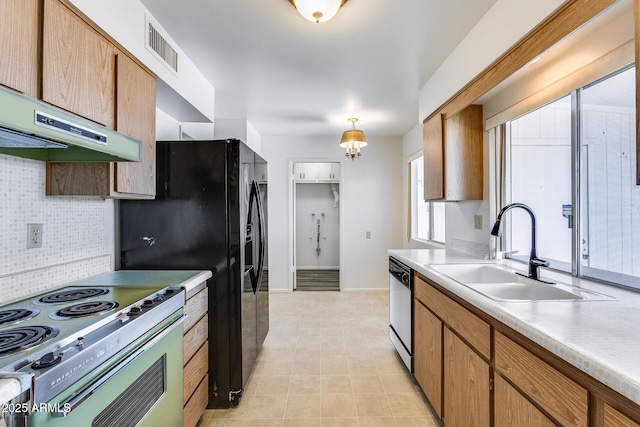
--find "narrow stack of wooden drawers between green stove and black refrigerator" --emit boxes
[183,282,209,427]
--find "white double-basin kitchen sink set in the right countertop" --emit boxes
[429,264,615,302]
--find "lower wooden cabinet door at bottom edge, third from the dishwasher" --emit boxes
[494,375,555,427]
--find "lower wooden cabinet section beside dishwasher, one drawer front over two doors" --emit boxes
[414,277,491,427]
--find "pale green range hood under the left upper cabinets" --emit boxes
[0,87,142,162]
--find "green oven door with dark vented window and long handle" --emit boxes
[30,313,184,427]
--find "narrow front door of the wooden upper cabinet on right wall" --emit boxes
[422,115,444,200]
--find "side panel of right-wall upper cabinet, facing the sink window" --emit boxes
[444,105,483,201]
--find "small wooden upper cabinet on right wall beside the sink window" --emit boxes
[423,105,483,201]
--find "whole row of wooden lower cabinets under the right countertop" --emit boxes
[414,273,640,427]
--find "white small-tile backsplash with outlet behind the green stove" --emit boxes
[0,155,113,303]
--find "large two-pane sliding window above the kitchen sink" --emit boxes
[503,64,640,288]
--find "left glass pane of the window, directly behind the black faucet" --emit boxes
[505,96,572,272]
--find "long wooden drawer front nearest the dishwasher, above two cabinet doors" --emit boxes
[414,277,491,359]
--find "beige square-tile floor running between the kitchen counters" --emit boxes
[200,292,437,427]
